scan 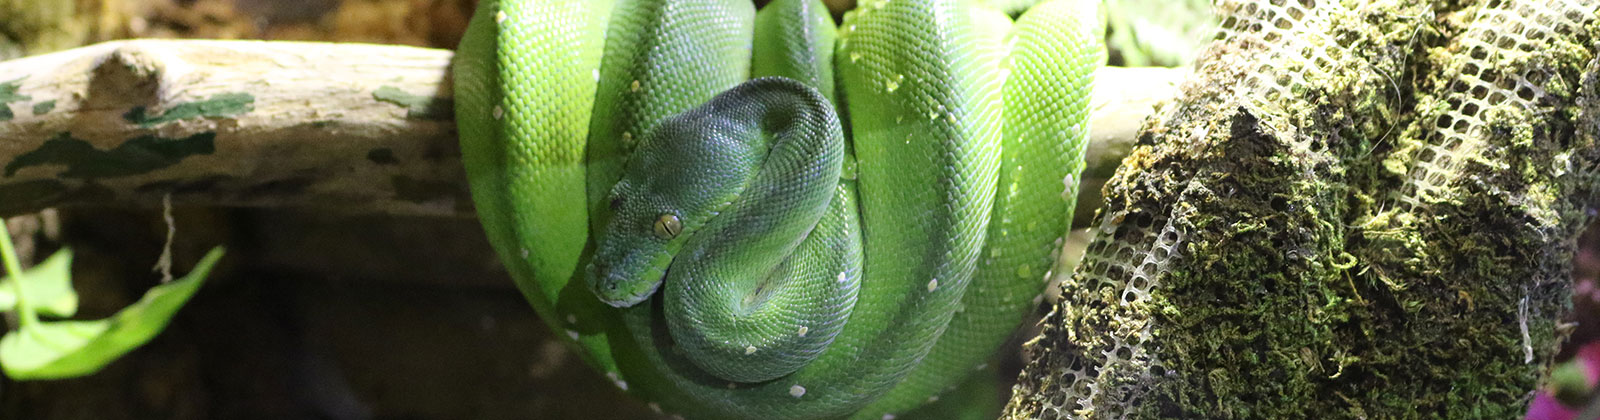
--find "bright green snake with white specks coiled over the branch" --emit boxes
[454,0,1104,418]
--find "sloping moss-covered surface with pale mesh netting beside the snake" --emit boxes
[1008,0,1600,418]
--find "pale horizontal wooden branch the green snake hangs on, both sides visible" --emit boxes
[0,40,1187,215]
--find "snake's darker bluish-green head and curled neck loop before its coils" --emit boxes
[590,79,861,383]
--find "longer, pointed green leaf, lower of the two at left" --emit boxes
[0,247,222,380]
